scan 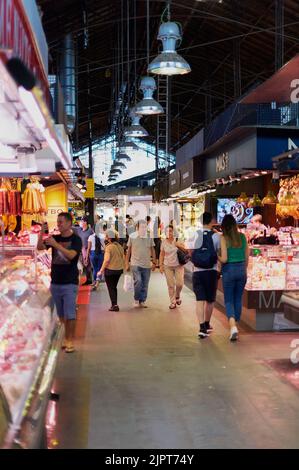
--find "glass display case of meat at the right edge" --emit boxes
[246,245,299,291]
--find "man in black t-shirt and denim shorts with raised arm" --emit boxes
[37,212,82,353]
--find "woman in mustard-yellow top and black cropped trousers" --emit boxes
[98,229,124,312]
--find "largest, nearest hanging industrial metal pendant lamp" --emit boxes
[147,21,191,75]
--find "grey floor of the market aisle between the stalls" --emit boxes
[50,273,299,449]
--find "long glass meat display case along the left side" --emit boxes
[0,246,63,448]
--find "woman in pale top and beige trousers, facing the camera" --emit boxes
[160,225,186,309]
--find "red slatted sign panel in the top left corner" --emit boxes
[0,0,48,97]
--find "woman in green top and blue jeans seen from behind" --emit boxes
[219,214,248,341]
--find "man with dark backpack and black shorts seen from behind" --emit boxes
[186,212,220,339]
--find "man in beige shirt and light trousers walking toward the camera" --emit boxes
[126,220,157,308]
